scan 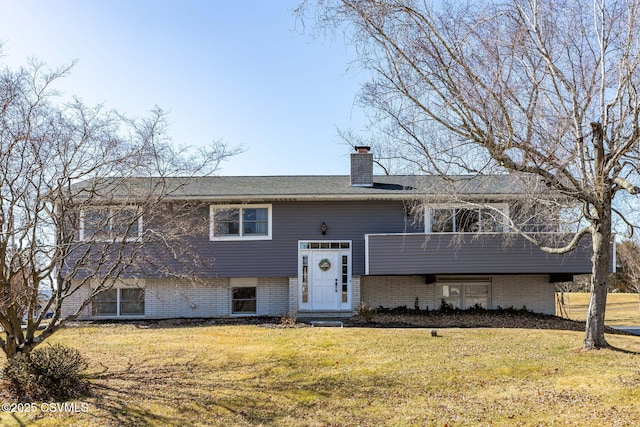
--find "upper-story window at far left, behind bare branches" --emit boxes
[80,206,142,240]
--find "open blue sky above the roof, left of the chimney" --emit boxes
[0,0,366,176]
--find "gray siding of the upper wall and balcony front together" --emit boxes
[70,200,591,278]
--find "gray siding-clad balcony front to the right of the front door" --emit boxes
[368,233,591,275]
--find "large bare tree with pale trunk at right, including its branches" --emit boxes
[297,0,640,349]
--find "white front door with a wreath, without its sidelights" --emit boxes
[309,251,342,310]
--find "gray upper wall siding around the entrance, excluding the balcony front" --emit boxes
[65,200,422,278]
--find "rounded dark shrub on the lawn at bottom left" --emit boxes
[4,344,89,401]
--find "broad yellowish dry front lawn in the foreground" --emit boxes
[2,324,640,426]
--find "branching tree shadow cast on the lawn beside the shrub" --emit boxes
[82,358,399,427]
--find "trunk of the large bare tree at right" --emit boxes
[583,204,611,350]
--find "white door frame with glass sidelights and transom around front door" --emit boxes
[297,240,353,312]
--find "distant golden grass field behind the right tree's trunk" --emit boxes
[558,292,640,326]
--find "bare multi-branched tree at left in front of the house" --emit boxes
[0,53,237,358]
